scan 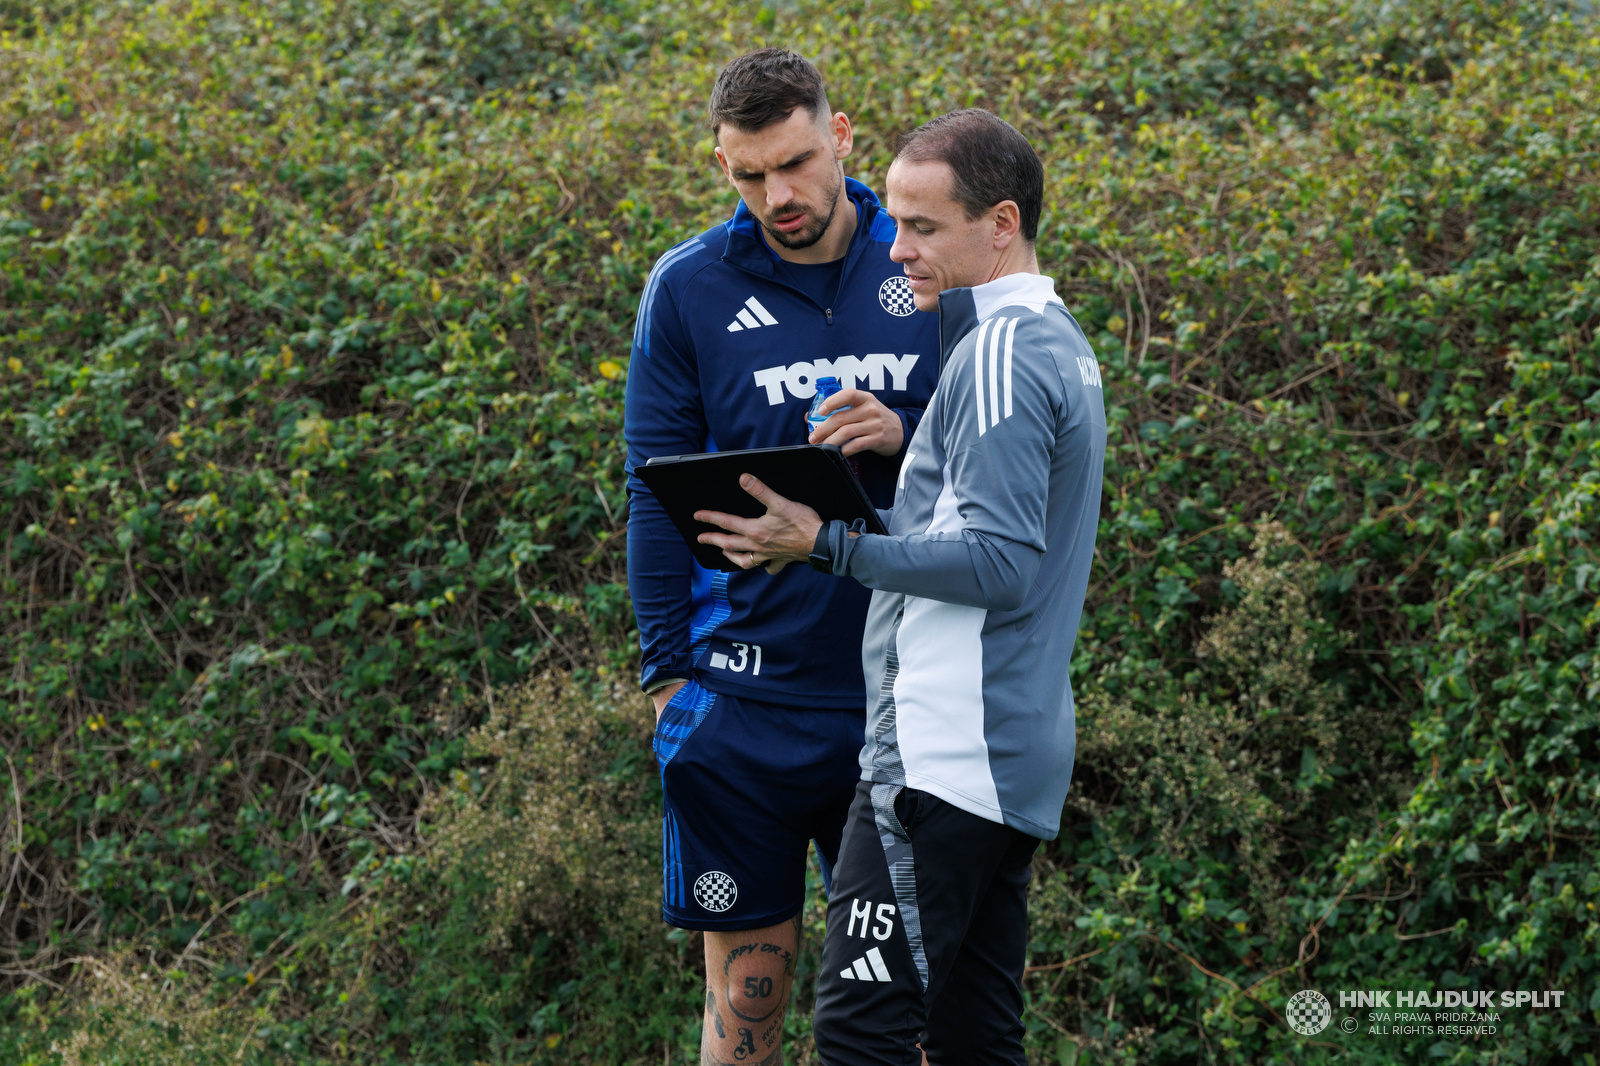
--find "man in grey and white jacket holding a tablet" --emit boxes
[701,110,1106,1066]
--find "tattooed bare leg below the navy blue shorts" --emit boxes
[701,916,800,1066]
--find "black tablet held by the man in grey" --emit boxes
[635,445,888,570]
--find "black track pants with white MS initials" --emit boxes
[813,781,1038,1066]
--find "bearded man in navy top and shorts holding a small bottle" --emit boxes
[626,48,939,1063]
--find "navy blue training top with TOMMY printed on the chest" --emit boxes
[624,179,939,707]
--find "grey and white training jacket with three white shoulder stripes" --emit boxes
[829,274,1106,840]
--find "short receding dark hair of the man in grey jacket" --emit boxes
[894,107,1045,243]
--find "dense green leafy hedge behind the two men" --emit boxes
[0,0,1600,1064]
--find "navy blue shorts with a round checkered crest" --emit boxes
[653,682,866,930]
